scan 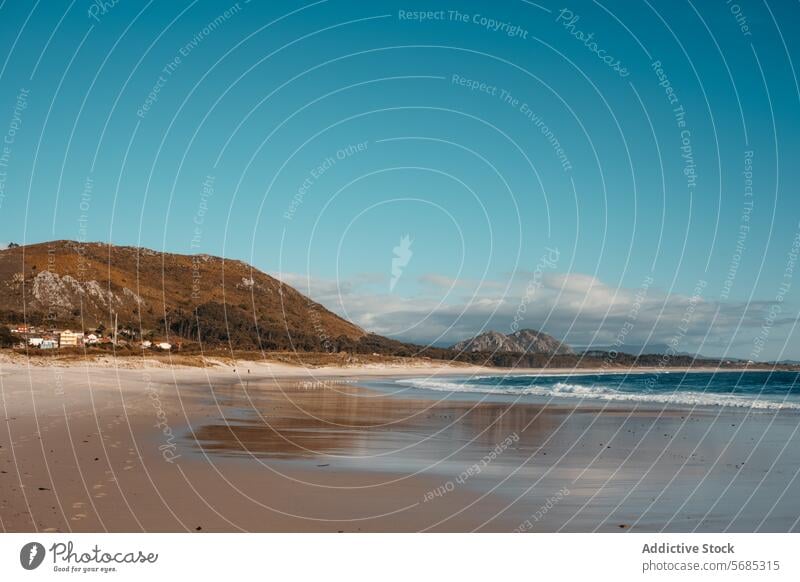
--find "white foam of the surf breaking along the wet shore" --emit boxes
[396,378,800,410]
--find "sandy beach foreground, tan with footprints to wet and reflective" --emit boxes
[0,364,800,532]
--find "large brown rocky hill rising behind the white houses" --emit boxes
[0,241,368,351]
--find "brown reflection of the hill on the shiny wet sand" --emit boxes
[192,382,554,459]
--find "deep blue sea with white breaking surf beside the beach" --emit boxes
[395,370,800,410]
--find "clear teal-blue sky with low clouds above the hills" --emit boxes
[0,0,800,359]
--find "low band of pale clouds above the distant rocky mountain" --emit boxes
[276,272,798,360]
